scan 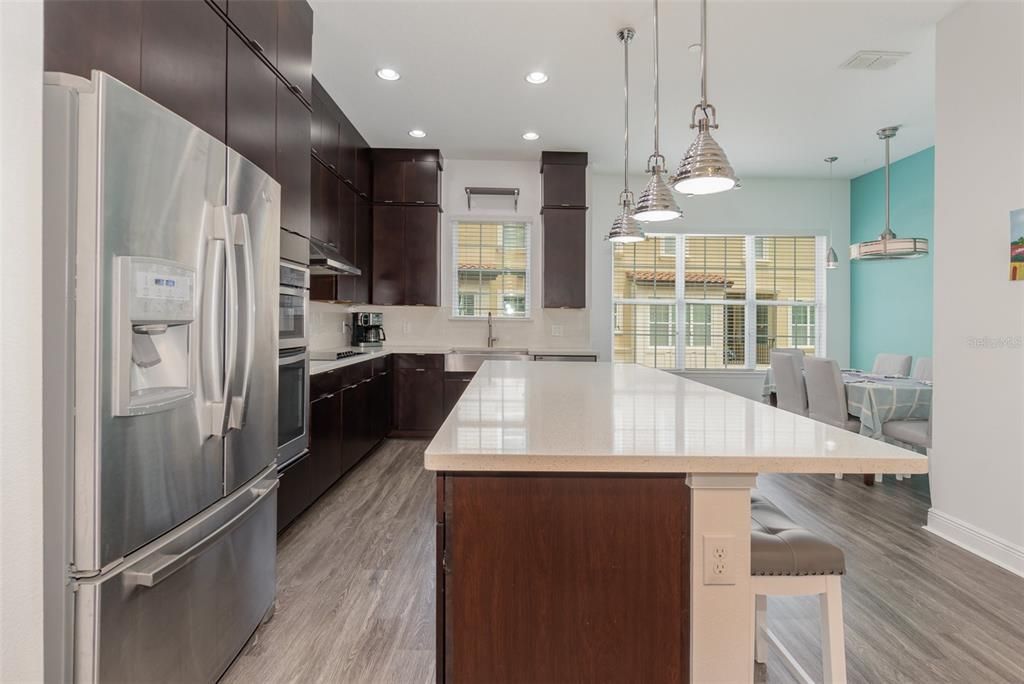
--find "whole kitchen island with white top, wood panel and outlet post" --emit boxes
[425,361,927,682]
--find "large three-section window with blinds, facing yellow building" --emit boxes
[612,236,825,370]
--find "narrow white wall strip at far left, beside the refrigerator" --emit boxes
[0,2,43,682]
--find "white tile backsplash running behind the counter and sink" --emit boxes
[309,302,590,349]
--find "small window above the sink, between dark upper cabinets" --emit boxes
[452,221,530,318]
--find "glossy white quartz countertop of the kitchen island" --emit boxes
[425,361,928,473]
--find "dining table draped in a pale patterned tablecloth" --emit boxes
[761,369,932,439]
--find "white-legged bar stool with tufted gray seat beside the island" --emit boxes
[751,494,846,684]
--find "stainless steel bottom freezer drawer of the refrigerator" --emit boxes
[75,467,278,682]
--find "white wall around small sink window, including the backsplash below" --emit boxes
[311,160,590,349]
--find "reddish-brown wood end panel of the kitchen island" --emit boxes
[438,473,690,684]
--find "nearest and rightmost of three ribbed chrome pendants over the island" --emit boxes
[672,0,737,195]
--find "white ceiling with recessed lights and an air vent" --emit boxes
[312,0,970,177]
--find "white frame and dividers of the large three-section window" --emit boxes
[610,233,827,373]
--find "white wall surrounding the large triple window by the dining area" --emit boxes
[590,173,850,398]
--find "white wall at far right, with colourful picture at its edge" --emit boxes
[928,2,1024,574]
